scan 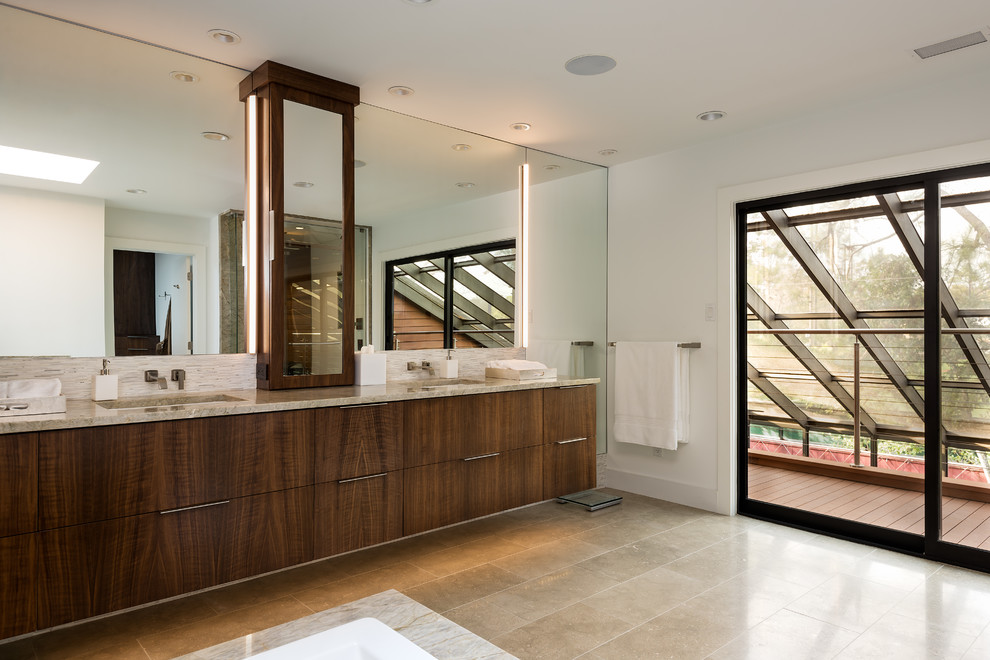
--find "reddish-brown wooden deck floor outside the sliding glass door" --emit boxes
[749,464,990,550]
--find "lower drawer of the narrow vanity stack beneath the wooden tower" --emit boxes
[314,470,402,558]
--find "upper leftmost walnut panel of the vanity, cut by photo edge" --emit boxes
[0,433,38,536]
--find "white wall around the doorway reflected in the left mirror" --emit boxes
[106,207,220,355]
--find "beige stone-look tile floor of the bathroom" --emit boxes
[0,494,990,660]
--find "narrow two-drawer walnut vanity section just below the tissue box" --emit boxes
[313,402,405,557]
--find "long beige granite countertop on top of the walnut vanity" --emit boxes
[0,378,599,434]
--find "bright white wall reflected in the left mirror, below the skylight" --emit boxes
[0,187,104,355]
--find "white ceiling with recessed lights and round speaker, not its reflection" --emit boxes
[12,0,990,165]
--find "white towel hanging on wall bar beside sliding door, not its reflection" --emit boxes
[612,342,690,449]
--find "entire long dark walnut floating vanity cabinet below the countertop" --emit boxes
[0,385,595,639]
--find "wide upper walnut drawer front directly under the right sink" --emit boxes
[403,390,543,467]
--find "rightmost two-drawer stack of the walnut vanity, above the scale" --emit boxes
[543,385,597,499]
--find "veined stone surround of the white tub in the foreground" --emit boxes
[179,589,515,660]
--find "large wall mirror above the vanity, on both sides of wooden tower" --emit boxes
[0,6,607,444]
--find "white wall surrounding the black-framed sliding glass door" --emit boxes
[607,64,990,513]
